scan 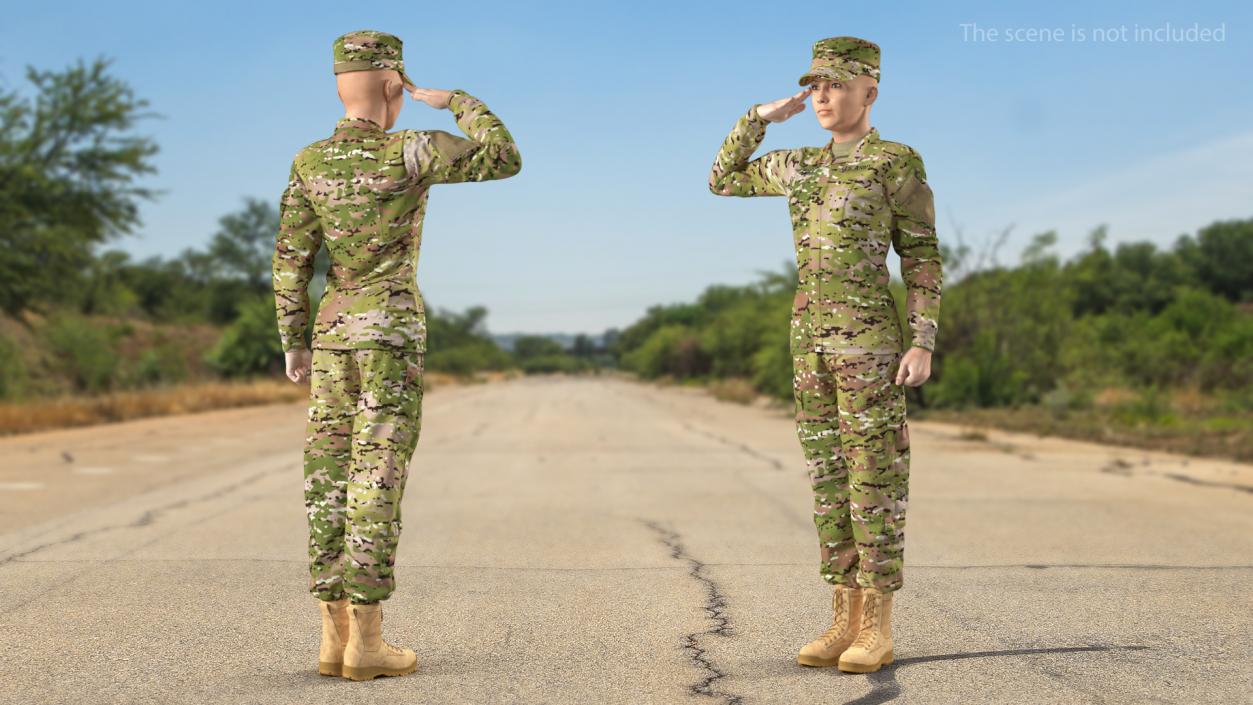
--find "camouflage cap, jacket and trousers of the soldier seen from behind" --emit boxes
[273,31,521,602]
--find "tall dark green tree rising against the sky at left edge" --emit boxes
[0,58,158,314]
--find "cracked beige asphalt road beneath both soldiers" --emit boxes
[0,378,1253,705]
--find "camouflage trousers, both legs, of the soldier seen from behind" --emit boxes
[304,348,424,602]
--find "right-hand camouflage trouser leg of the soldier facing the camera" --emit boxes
[831,353,910,592]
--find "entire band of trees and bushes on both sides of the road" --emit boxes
[0,60,1253,416]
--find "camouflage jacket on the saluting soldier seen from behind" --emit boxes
[273,89,521,352]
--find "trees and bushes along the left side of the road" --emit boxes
[0,59,608,399]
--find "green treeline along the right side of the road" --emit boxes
[614,219,1253,411]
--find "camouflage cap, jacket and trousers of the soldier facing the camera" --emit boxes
[709,38,941,591]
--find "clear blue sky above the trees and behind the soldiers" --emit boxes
[0,0,1253,333]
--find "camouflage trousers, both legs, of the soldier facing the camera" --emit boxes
[792,353,910,591]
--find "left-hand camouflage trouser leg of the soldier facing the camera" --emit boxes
[792,353,857,585]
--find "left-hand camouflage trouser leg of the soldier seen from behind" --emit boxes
[304,348,358,600]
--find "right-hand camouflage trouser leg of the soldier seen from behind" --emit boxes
[343,349,424,604]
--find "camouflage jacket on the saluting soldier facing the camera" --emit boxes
[709,105,941,353]
